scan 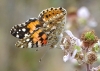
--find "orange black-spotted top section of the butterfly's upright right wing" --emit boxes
[38,7,66,23]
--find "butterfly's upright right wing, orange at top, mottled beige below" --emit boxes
[38,7,66,47]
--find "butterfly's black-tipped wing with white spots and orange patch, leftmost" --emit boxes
[10,18,41,39]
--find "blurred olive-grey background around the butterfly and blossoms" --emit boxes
[0,0,100,71]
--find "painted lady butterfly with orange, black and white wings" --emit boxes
[10,7,66,48]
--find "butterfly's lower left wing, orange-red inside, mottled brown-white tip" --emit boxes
[16,29,47,48]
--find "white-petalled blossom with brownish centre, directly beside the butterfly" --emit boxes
[60,30,82,62]
